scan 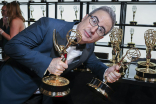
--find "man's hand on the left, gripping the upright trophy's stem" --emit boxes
[47,58,68,75]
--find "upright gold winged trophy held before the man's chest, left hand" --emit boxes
[40,29,82,97]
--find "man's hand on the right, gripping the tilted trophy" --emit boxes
[104,65,121,83]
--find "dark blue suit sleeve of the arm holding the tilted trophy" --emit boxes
[84,45,108,80]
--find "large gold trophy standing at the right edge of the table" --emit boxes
[134,29,156,82]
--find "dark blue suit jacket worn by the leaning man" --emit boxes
[0,17,107,104]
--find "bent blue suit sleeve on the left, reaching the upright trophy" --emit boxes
[4,18,52,77]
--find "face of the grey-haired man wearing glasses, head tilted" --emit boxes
[77,10,112,44]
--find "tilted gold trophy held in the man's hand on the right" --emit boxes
[87,48,141,100]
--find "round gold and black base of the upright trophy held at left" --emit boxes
[40,75,70,97]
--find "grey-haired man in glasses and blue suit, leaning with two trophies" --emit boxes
[0,6,120,104]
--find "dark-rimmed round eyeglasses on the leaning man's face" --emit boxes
[89,15,106,36]
